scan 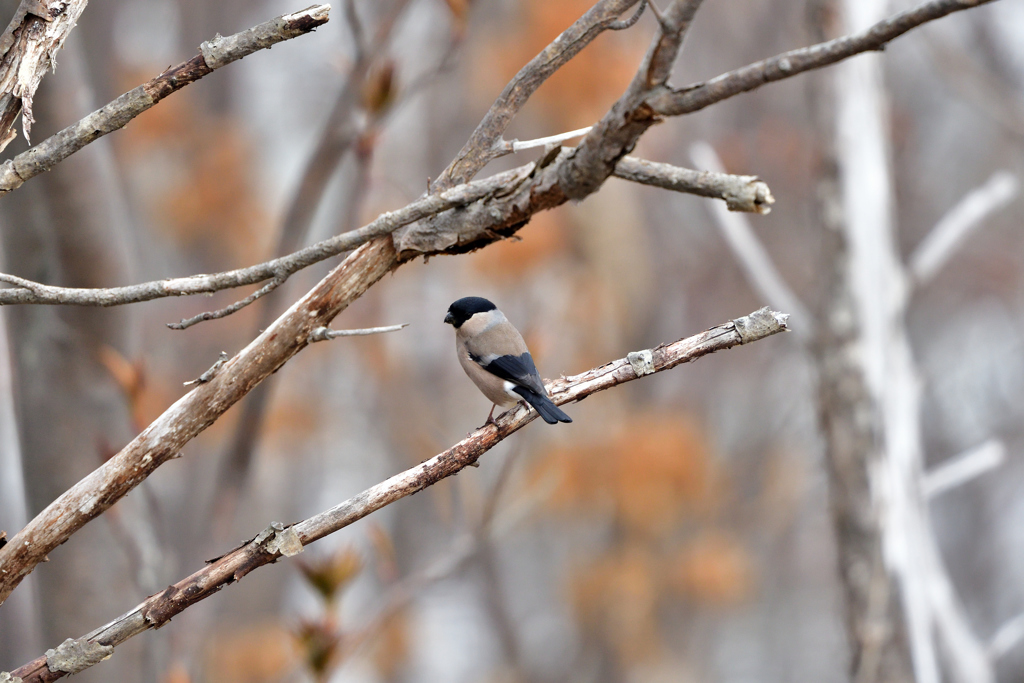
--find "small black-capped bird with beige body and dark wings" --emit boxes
[444,297,572,425]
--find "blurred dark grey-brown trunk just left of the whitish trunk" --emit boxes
[809,0,913,683]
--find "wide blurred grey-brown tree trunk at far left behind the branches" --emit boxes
[0,38,142,681]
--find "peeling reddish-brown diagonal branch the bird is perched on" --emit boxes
[4,308,787,683]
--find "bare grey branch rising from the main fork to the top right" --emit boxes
[647,0,992,116]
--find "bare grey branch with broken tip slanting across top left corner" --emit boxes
[0,2,331,196]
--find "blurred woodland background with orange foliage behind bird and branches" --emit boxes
[0,0,1024,683]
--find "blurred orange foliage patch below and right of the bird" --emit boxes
[529,414,754,664]
